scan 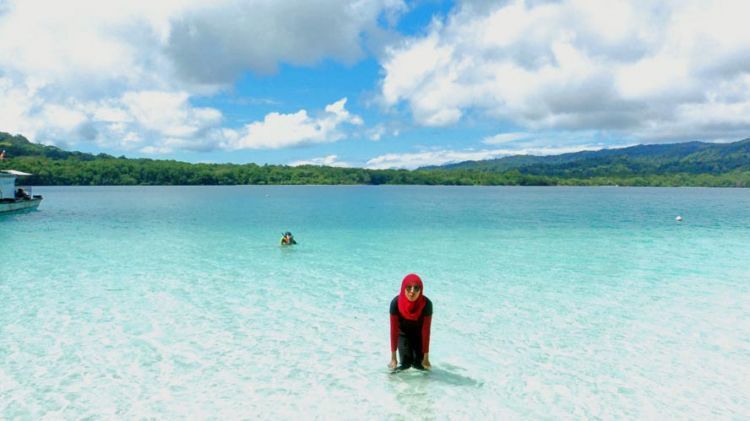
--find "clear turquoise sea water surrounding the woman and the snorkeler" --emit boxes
[0,186,750,419]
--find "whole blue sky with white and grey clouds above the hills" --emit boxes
[0,0,750,169]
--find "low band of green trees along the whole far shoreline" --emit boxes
[0,156,750,187]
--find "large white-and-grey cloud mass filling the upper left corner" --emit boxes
[0,0,406,91]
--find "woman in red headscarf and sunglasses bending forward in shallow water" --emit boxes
[388,273,432,370]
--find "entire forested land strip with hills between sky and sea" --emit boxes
[0,132,750,187]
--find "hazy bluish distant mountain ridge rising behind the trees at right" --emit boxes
[430,138,750,178]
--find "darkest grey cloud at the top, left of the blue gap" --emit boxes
[166,0,406,83]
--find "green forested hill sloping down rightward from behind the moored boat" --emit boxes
[0,132,488,185]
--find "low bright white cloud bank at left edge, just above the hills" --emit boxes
[0,84,222,151]
